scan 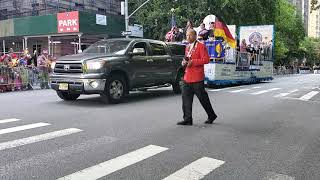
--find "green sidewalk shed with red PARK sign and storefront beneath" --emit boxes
[0,11,125,57]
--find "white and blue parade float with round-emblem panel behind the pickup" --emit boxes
[203,15,274,86]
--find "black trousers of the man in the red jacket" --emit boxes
[182,81,216,122]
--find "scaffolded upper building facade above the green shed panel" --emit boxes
[0,0,121,20]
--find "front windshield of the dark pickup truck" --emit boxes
[83,40,130,55]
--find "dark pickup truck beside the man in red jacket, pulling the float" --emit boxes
[50,38,185,103]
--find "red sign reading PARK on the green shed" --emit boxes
[57,11,79,33]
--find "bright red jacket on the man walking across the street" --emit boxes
[184,42,210,83]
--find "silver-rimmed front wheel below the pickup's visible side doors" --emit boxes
[101,75,127,104]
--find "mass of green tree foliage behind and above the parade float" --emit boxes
[129,0,317,65]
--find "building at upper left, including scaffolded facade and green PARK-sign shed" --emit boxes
[0,0,125,57]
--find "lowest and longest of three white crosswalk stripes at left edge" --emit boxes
[0,128,82,151]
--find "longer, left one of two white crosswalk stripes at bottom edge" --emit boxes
[58,145,168,180]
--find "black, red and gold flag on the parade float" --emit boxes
[214,17,237,48]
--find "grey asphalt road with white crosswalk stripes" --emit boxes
[0,74,320,180]
